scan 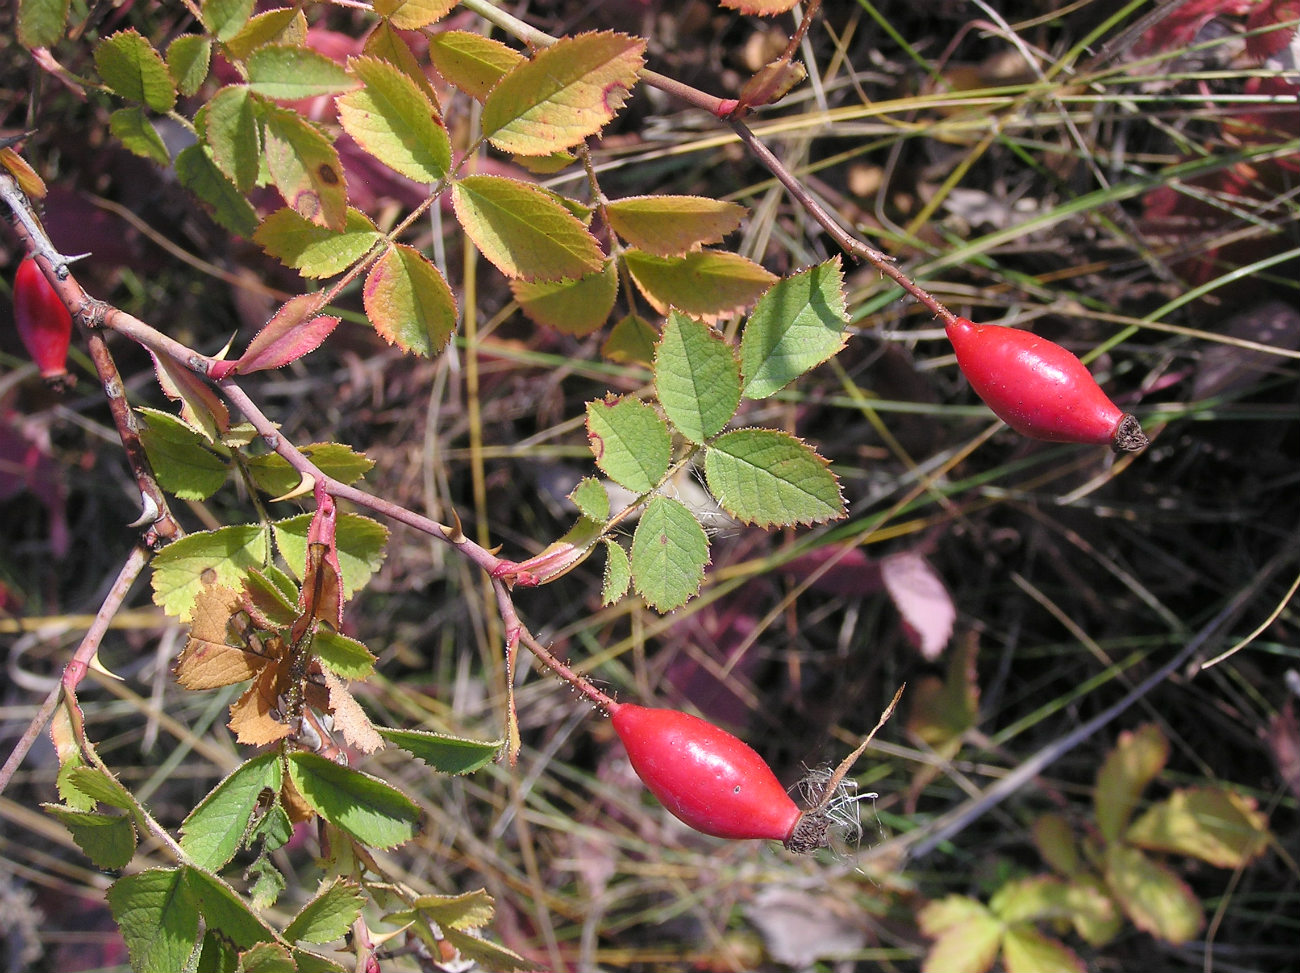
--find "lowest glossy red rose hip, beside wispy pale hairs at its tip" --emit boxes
[610,702,801,842]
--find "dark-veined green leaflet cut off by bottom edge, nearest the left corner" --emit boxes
[108,869,199,973]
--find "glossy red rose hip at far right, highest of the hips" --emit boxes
[946,317,1147,453]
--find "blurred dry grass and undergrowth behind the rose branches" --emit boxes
[0,0,1300,973]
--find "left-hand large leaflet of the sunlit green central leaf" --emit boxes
[586,395,672,493]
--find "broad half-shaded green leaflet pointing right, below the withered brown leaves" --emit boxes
[289,752,420,848]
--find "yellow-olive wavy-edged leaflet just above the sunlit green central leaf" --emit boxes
[623,250,776,324]
